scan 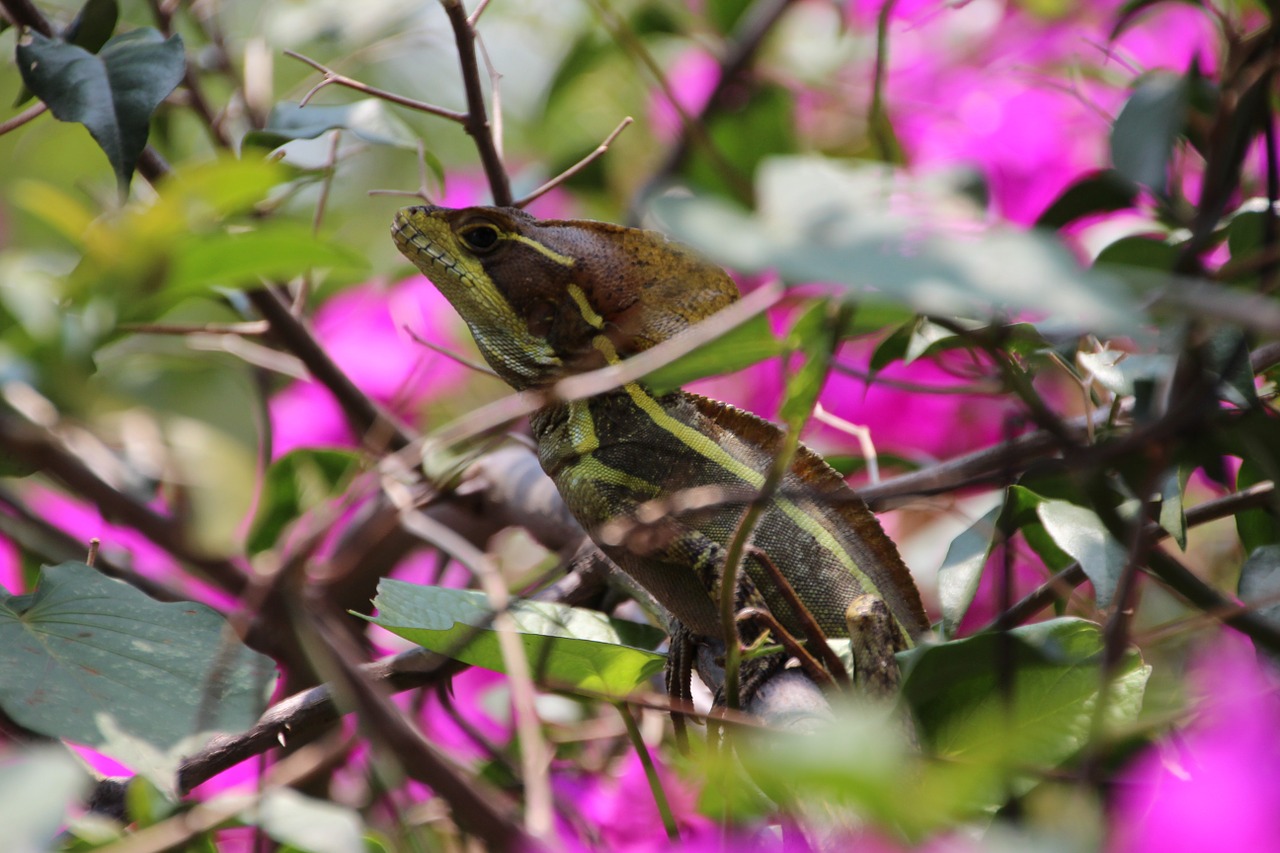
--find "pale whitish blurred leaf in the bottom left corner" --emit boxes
[0,744,91,853]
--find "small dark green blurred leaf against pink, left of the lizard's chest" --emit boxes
[244,448,360,555]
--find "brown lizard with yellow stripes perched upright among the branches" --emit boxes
[392,206,929,699]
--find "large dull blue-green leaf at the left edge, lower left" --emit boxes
[0,562,274,790]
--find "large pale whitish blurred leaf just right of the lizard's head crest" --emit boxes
[653,158,1140,333]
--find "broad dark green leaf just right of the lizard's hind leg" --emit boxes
[899,619,1151,773]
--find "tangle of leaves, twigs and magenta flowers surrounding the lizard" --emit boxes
[0,0,1280,852]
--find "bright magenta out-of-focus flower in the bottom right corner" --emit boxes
[1108,633,1280,853]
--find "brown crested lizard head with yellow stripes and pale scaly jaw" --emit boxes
[392,206,737,388]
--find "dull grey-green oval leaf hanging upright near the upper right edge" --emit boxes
[1111,74,1188,196]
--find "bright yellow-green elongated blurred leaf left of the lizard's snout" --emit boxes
[165,220,367,298]
